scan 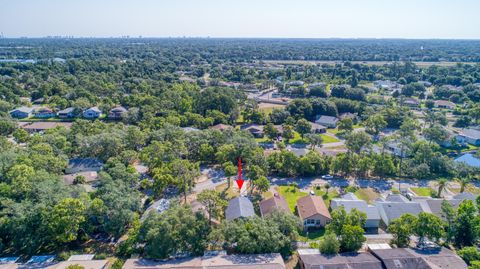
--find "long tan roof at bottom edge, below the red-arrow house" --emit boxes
[122,253,285,269]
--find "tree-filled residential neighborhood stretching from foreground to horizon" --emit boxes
[0,38,480,269]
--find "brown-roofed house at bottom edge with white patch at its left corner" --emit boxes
[298,249,383,269]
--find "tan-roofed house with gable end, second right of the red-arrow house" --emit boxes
[297,195,332,230]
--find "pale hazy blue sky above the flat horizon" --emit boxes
[0,0,480,39]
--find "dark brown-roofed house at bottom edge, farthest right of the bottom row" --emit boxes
[370,248,468,269]
